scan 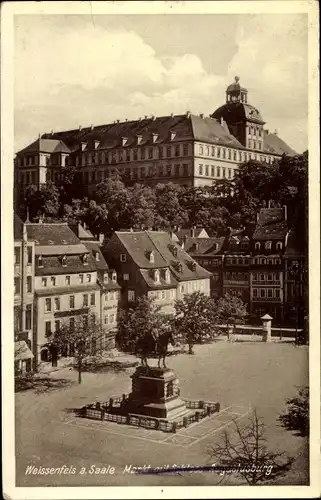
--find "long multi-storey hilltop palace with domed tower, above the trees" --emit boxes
[15,77,296,193]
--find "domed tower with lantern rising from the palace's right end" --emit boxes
[211,76,265,151]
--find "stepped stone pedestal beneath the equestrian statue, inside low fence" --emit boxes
[126,366,188,420]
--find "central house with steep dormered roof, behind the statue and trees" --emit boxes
[103,231,211,314]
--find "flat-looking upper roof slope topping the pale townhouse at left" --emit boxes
[26,223,81,246]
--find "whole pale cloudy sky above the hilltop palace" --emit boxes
[14,14,308,153]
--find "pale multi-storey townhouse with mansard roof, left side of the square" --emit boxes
[26,223,100,365]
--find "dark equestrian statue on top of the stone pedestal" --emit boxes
[135,331,175,368]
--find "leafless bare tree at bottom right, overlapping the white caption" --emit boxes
[208,411,293,486]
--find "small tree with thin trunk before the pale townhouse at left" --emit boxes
[47,314,105,384]
